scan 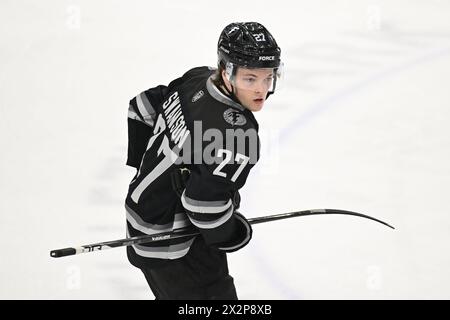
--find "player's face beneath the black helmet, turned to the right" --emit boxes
[222,67,273,112]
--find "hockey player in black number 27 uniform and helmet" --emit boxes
[125,22,282,300]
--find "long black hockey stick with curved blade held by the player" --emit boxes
[50,209,395,258]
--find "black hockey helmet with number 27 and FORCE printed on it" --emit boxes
[217,22,281,68]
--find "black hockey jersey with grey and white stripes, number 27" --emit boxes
[125,67,259,267]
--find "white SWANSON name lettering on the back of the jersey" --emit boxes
[162,91,189,148]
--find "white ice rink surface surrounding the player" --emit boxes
[0,0,450,299]
